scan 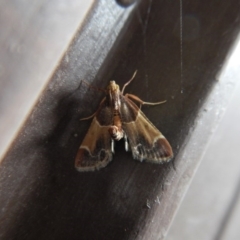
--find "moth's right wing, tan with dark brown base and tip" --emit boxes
[121,96,173,163]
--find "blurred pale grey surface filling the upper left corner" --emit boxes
[0,0,93,161]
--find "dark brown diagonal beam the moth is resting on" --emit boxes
[0,0,239,240]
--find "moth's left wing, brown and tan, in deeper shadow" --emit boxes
[75,98,112,172]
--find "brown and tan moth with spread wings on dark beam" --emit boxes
[75,72,173,172]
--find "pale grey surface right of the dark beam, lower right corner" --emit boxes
[166,62,240,240]
